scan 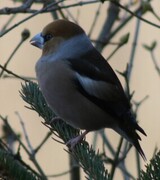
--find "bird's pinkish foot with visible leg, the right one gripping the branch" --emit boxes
[66,130,89,150]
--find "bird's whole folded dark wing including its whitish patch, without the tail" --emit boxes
[69,49,130,117]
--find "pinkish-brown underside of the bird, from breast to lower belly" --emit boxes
[37,60,114,130]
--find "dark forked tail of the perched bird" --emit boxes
[115,113,147,161]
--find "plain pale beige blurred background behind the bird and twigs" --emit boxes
[0,0,160,180]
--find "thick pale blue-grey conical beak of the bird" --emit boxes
[30,33,44,49]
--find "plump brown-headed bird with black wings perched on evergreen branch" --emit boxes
[30,19,146,160]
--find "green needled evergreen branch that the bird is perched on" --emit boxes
[20,82,110,180]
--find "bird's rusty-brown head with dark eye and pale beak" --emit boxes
[30,20,85,55]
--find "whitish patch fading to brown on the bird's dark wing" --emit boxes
[76,73,118,101]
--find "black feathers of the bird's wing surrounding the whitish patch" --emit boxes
[69,49,130,117]
